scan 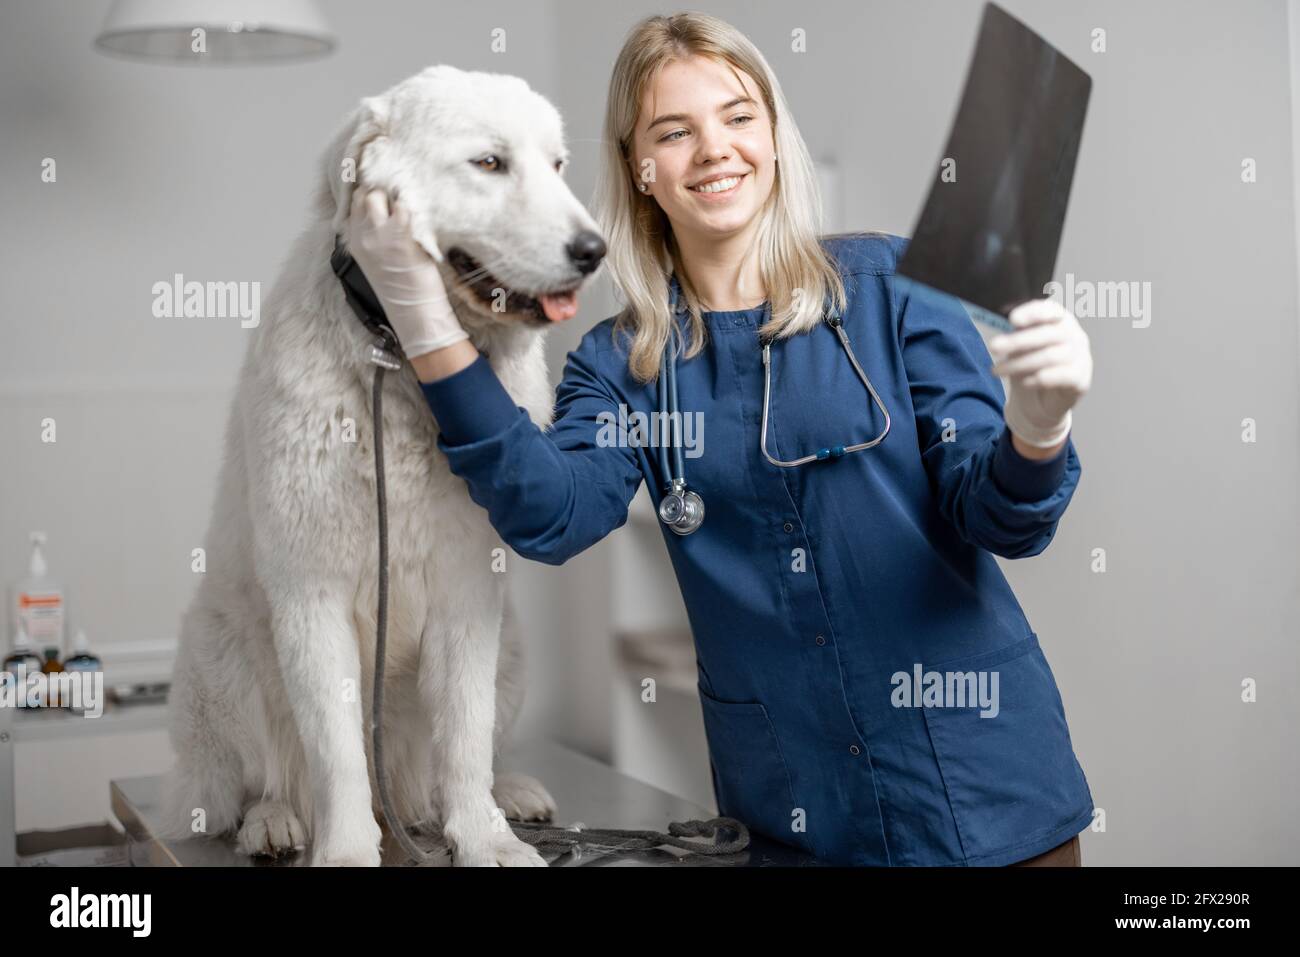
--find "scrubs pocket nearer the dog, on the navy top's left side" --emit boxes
[699,688,800,844]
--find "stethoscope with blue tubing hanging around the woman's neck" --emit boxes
[658,276,889,534]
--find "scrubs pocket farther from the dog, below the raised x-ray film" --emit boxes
[922,632,1092,863]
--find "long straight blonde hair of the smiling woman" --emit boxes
[594,13,845,382]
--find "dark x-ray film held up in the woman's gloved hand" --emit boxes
[897,4,1092,332]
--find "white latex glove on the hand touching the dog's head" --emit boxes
[347,186,469,359]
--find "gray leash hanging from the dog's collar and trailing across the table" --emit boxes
[366,338,749,863]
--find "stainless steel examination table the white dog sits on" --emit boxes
[111,740,816,867]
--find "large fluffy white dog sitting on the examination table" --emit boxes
[164,66,603,866]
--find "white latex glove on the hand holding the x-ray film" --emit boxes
[988,299,1092,449]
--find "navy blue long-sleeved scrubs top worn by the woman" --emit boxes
[423,234,1093,866]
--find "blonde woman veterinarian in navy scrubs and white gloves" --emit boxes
[358,14,1093,865]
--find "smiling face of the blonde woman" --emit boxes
[629,56,776,250]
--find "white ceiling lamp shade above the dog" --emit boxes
[95,0,335,65]
